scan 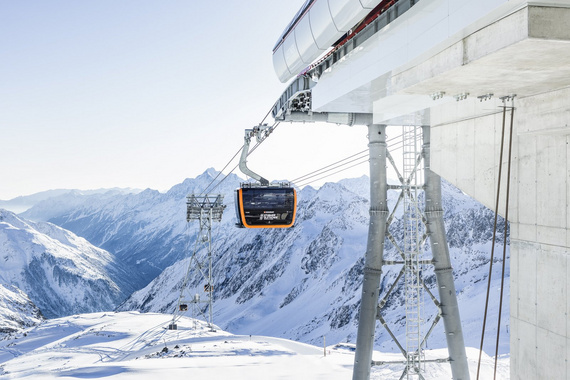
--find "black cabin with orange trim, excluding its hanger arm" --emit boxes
[235,184,297,228]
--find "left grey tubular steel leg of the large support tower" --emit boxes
[352,124,388,380]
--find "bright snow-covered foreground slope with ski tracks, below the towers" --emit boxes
[0,312,509,380]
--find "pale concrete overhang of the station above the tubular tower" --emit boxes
[373,6,570,125]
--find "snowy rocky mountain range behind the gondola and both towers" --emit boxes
[16,169,509,353]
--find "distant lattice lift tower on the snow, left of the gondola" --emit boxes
[168,194,226,330]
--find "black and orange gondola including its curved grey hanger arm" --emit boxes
[235,125,297,228]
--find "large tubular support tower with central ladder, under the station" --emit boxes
[353,124,469,380]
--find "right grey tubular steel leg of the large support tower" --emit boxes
[423,126,469,380]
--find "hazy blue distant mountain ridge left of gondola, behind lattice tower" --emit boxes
[22,169,240,289]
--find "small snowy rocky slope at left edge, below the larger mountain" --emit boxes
[0,284,44,336]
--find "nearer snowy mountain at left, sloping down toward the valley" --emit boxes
[0,209,132,319]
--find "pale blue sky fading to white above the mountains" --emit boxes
[0,0,367,199]
